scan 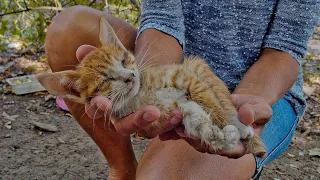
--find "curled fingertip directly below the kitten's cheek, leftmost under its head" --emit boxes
[85,96,112,119]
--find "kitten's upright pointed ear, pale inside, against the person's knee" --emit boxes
[99,17,126,50]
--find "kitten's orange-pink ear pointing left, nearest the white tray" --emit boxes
[38,70,86,104]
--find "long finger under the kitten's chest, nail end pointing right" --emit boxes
[113,106,160,135]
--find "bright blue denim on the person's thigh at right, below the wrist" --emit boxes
[253,98,299,178]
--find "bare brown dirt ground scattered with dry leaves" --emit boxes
[0,27,320,180]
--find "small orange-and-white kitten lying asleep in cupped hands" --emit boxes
[38,18,266,157]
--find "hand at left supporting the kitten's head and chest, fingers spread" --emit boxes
[76,45,182,138]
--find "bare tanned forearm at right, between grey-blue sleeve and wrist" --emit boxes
[234,48,299,106]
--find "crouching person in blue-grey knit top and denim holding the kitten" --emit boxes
[45,0,320,179]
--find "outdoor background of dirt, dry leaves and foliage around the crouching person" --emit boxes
[0,0,320,180]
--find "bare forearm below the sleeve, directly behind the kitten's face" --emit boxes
[134,29,183,66]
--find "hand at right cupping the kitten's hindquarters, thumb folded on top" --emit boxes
[159,94,272,158]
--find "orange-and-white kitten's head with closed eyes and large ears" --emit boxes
[38,18,140,107]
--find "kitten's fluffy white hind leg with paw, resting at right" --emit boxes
[179,101,240,150]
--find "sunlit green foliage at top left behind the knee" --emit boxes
[0,0,140,51]
